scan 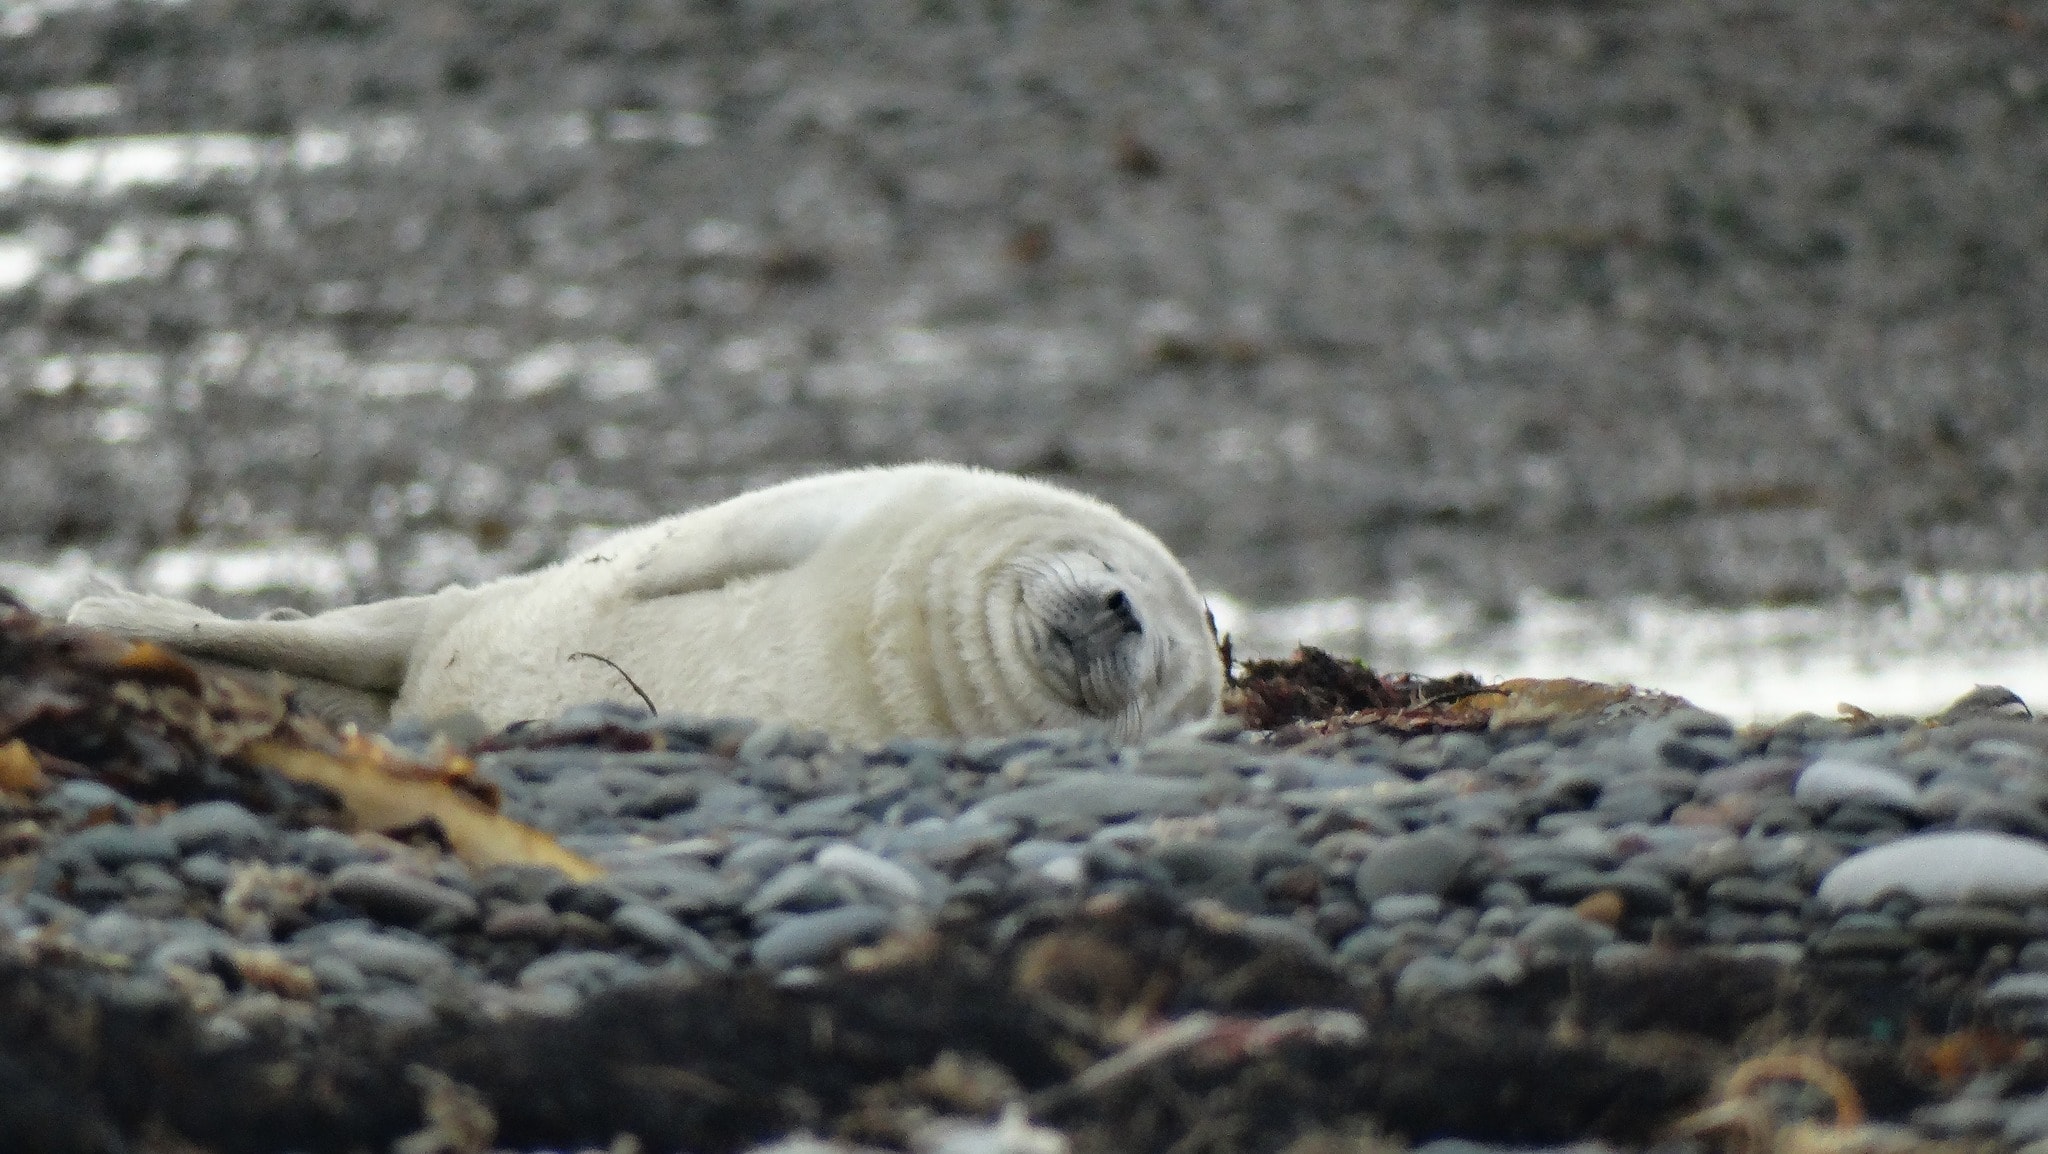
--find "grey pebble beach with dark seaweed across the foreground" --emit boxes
[12,611,2048,1154]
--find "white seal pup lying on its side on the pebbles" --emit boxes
[70,463,1223,740]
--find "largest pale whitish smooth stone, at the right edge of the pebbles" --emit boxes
[1819,832,2048,906]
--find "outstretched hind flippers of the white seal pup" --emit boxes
[70,590,440,693]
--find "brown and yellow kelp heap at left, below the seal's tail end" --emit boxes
[0,590,602,879]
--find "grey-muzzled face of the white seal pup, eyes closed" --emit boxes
[1014,549,1221,740]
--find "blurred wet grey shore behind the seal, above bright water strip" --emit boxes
[0,0,2048,623]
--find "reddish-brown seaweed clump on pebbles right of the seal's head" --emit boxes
[1223,646,1686,744]
